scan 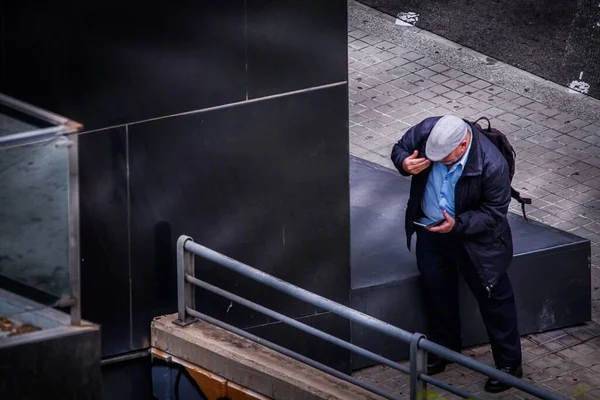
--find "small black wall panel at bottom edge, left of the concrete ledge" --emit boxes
[102,357,152,400]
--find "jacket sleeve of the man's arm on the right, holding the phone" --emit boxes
[452,162,510,235]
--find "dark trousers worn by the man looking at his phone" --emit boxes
[416,229,521,367]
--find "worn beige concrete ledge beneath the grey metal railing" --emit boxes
[151,314,383,400]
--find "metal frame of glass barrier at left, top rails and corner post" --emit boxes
[0,93,83,325]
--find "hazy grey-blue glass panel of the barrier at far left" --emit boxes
[0,117,70,299]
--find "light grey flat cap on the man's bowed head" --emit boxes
[425,115,469,161]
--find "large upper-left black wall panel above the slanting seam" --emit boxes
[0,0,246,130]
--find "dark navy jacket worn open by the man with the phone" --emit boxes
[392,117,513,291]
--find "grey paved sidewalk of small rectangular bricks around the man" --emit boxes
[348,1,600,399]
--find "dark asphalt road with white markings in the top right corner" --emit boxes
[360,0,600,98]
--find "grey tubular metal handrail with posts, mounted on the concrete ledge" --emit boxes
[175,236,565,400]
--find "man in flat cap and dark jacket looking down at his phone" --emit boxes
[391,116,523,392]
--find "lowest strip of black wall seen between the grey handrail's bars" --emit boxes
[248,312,351,373]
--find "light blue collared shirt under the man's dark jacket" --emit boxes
[421,134,473,221]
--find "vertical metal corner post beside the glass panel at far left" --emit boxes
[67,134,81,325]
